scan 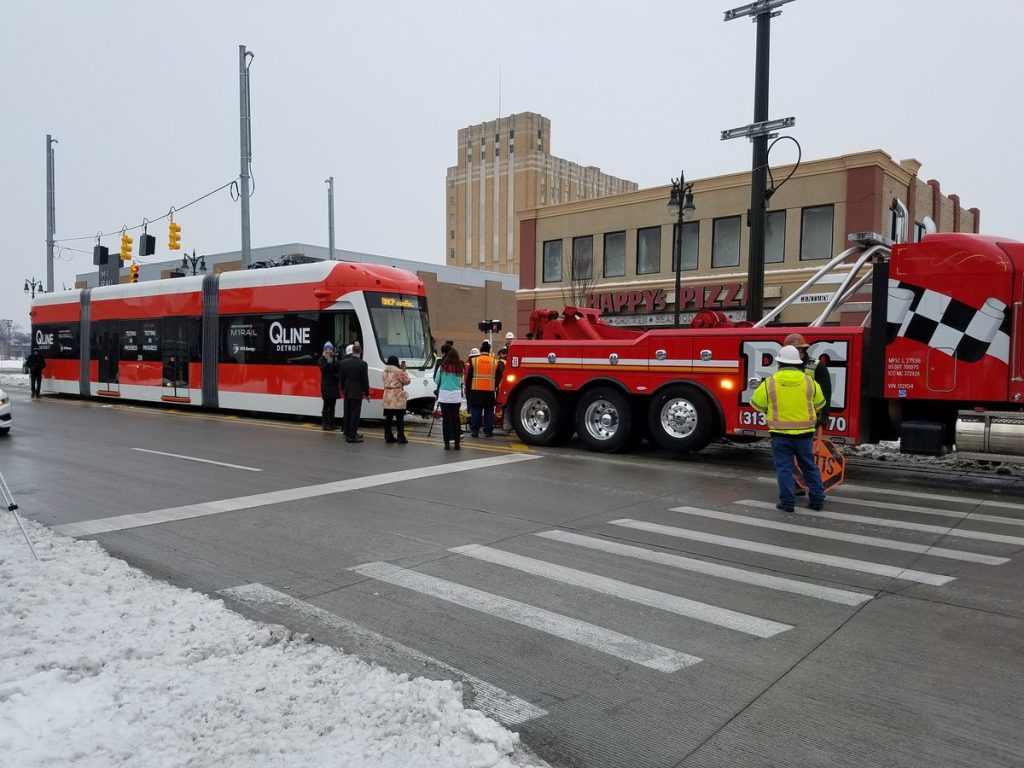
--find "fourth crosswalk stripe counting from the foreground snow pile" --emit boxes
[535,530,872,605]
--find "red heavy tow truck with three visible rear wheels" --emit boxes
[498,228,1024,461]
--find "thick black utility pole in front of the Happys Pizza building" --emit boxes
[722,0,797,323]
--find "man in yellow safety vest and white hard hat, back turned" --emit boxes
[751,345,827,512]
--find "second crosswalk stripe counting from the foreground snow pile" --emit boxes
[350,561,701,672]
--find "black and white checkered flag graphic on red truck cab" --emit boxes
[886,280,1011,362]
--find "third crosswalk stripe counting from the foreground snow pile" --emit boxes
[449,544,793,637]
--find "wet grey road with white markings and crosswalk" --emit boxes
[0,387,1024,768]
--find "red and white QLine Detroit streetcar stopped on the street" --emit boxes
[31,261,434,419]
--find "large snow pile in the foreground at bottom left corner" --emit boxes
[0,518,538,768]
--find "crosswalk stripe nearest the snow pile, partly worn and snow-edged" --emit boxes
[218,584,548,725]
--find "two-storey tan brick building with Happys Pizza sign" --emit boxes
[517,151,980,334]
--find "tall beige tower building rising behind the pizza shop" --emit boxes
[444,112,637,274]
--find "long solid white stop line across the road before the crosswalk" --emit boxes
[53,454,540,537]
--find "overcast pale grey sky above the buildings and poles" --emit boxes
[0,0,1024,325]
